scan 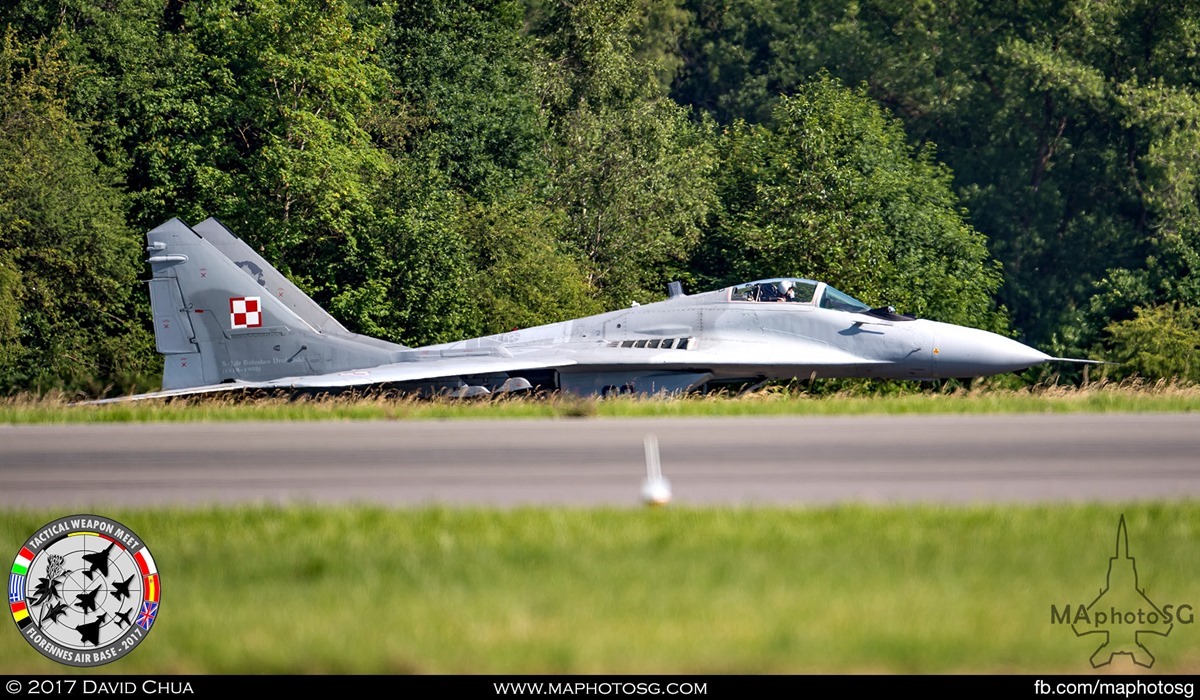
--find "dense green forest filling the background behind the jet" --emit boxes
[0,0,1200,395]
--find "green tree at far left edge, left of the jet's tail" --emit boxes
[0,29,152,394]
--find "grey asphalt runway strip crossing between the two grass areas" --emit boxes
[0,414,1200,511]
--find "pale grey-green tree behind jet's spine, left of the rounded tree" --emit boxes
[534,0,715,307]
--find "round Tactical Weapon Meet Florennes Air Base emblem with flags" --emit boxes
[8,515,162,666]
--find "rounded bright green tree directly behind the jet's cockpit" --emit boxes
[696,76,1003,329]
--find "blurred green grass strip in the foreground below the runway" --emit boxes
[0,502,1200,674]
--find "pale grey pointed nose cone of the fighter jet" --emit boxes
[934,324,1051,377]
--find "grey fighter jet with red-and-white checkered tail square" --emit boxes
[96,219,1093,401]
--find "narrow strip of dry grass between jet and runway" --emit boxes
[7,383,1200,424]
